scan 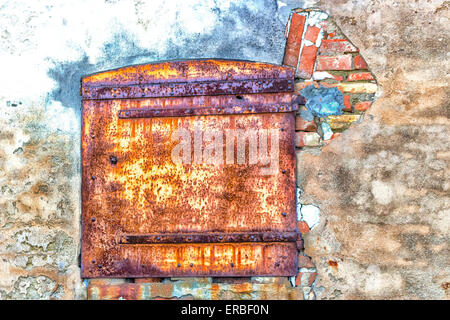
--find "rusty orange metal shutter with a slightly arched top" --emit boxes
[82,60,301,277]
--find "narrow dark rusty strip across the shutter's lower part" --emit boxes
[119,232,301,244]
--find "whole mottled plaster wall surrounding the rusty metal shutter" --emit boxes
[0,0,450,299]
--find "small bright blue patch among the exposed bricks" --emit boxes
[300,85,345,121]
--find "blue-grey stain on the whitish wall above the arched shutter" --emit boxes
[48,0,292,115]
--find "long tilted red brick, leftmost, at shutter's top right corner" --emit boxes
[283,13,306,68]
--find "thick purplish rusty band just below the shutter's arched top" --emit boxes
[81,79,294,100]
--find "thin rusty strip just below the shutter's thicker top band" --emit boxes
[119,104,298,119]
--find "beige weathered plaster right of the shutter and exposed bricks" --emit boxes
[300,0,450,299]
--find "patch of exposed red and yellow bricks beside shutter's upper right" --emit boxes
[285,10,377,148]
